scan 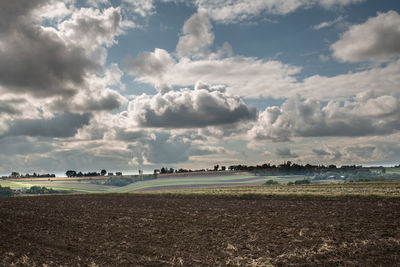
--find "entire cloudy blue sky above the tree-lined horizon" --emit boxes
[0,0,400,174]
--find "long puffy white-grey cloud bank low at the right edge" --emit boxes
[249,94,400,142]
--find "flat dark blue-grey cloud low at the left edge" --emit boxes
[0,112,91,138]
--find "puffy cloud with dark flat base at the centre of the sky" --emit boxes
[128,85,257,128]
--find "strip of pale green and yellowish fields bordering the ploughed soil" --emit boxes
[0,173,400,197]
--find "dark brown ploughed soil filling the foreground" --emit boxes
[0,194,400,266]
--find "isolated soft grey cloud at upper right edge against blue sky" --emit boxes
[331,10,400,62]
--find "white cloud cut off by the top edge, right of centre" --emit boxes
[194,0,364,23]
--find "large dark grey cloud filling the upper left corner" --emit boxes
[0,0,98,97]
